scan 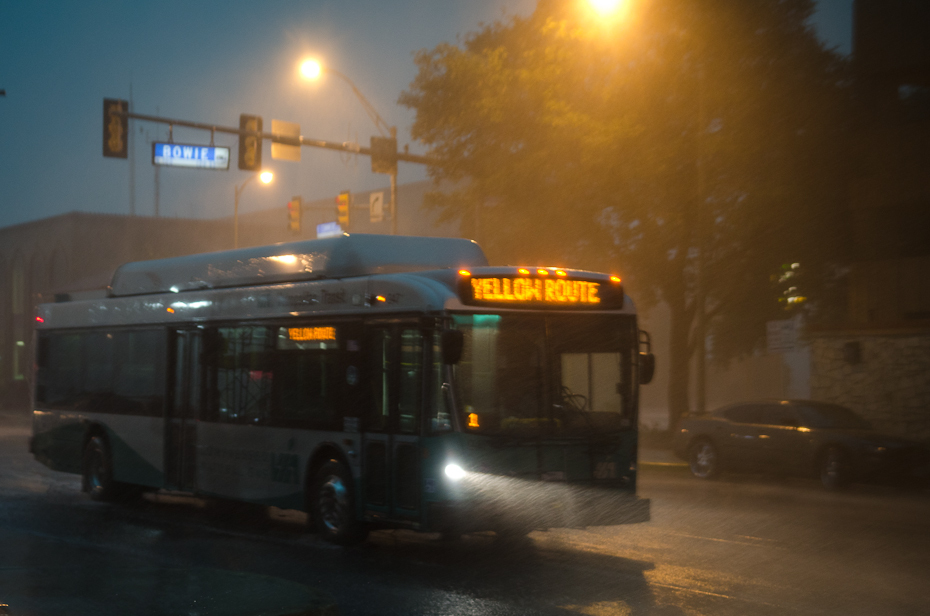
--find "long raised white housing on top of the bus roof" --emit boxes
[110,233,488,296]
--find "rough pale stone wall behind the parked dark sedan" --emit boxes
[811,330,930,438]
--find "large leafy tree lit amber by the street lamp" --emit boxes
[400,0,848,422]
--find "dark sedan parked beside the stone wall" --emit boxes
[674,400,930,490]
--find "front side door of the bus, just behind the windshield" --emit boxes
[362,324,423,521]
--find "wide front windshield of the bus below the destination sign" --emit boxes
[453,313,636,437]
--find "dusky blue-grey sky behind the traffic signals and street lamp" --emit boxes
[0,0,853,227]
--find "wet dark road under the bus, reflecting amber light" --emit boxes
[0,416,930,616]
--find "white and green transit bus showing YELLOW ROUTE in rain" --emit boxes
[30,234,654,544]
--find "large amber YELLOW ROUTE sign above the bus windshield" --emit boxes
[460,276,623,309]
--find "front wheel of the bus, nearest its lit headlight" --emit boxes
[310,460,368,545]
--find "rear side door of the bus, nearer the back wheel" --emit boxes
[165,330,202,491]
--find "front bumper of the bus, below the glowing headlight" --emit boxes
[428,482,650,532]
